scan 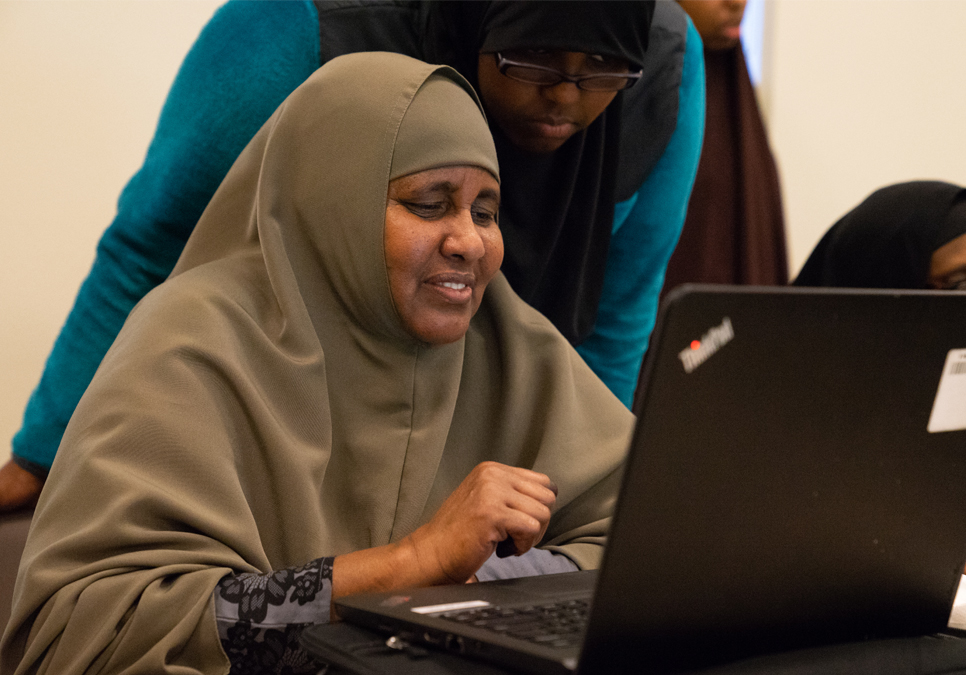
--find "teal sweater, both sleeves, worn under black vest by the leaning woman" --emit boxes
[13,1,704,474]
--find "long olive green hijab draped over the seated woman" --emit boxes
[0,53,632,675]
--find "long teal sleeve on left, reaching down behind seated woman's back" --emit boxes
[13,1,319,473]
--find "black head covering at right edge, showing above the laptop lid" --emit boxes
[794,181,966,288]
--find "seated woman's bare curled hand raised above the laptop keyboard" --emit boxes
[406,462,557,583]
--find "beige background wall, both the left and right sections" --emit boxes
[0,0,966,468]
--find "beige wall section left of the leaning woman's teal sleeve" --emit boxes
[0,0,221,461]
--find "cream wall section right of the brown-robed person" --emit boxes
[759,0,966,272]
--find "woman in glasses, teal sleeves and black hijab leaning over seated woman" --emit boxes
[0,0,704,509]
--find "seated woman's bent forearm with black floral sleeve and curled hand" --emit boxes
[213,462,575,667]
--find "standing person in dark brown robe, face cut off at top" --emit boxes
[664,0,788,292]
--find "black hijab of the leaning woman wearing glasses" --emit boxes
[424,1,660,344]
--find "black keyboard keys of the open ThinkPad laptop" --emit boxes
[438,600,590,647]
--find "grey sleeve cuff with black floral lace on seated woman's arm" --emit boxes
[214,558,334,675]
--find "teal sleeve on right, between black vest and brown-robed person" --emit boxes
[577,19,705,407]
